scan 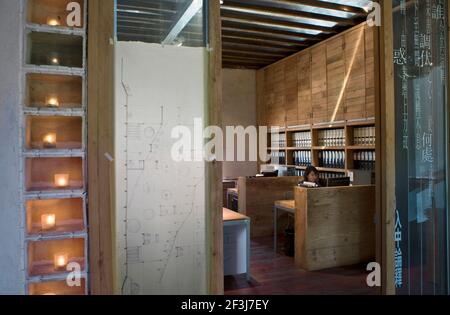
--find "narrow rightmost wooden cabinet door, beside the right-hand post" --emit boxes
[365,26,376,118]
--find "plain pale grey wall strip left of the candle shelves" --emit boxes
[0,0,25,294]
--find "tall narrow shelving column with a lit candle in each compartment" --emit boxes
[21,0,89,295]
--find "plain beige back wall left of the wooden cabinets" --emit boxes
[222,69,257,178]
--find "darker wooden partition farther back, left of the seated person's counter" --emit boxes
[238,176,303,237]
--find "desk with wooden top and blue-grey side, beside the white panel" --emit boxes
[223,208,250,281]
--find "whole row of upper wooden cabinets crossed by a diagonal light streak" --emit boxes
[258,23,378,126]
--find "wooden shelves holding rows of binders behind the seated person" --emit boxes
[268,119,375,178]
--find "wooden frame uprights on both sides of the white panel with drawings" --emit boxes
[87,0,224,295]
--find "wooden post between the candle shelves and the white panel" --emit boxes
[88,0,114,295]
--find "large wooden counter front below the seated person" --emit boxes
[295,186,375,271]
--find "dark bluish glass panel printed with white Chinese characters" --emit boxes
[392,0,448,294]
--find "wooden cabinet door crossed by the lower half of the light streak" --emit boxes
[327,36,345,122]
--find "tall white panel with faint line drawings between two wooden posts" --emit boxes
[115,42,207,295]
